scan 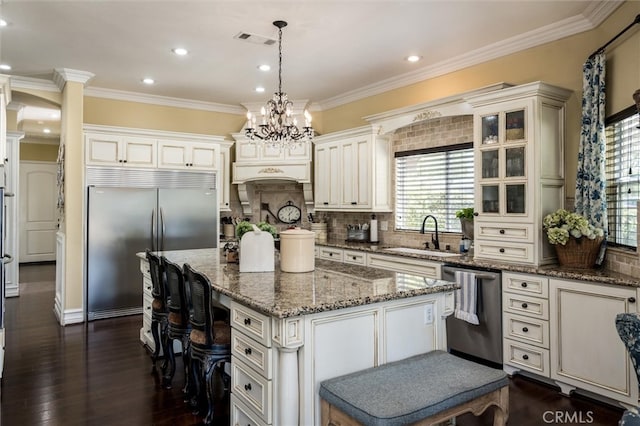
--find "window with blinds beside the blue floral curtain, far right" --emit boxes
[605,105,640,248]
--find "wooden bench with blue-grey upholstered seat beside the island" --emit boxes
[320,351,509,426]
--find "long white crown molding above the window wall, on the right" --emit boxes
[314,1,623,110]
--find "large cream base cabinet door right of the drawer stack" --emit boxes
[549,278,639,407]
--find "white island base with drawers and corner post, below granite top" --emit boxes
[231,292,453,426]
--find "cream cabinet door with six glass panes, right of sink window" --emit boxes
[476,107,528,220]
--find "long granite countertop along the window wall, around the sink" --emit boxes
[316,240,640,287]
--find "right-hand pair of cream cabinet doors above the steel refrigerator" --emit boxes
[158,140,220,171]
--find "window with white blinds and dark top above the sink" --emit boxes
[395,142,474,232]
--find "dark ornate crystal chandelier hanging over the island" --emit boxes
[245,21,313,148]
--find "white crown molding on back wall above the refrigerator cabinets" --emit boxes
[84,87,246,115]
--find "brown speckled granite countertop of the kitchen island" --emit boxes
[151,248,459,318]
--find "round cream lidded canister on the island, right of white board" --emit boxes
[280,228,316,272]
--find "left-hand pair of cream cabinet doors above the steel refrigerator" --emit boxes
[85,132,158,168]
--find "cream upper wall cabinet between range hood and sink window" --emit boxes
[314,126,391,212]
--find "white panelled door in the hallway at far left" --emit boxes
[18,161,58,263]
